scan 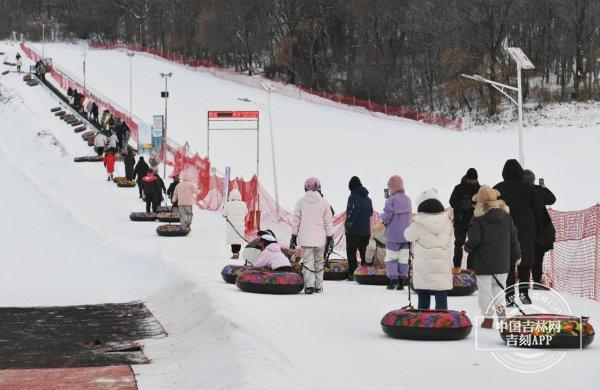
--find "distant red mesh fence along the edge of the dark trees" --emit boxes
[90,41,462,131]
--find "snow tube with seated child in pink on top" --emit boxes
[235,269,304,294]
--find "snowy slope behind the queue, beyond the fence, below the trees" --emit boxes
[29,43,600,211]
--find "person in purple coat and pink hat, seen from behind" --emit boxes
[379,175,412,290]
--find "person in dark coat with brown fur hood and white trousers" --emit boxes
[465,185,521,328]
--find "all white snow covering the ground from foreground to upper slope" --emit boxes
[0,43,600,389]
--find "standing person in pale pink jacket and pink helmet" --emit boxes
[290,177,333,294]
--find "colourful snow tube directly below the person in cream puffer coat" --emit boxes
[381,308,473,340]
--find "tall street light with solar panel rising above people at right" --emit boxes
[461,47,535,167]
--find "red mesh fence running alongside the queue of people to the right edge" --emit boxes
[21,44,600,301]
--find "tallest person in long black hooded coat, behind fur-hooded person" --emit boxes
[494,159,544,305]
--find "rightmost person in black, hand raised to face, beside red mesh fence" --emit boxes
[523,169,556,289]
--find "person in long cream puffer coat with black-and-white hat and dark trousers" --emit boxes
[404,188,453,310]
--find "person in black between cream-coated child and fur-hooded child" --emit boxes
[450,168,481,273]
